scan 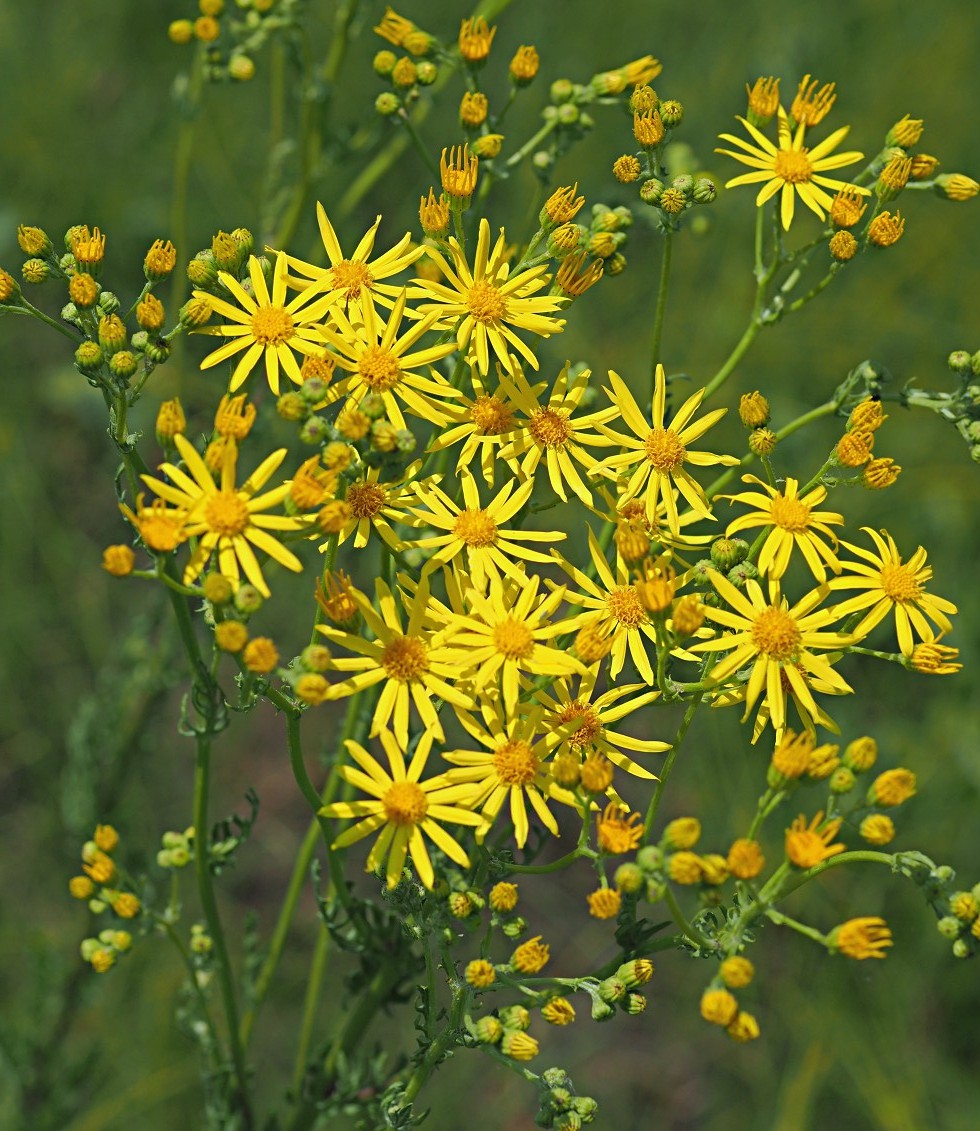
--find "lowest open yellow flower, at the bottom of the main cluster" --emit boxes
[320,731,480,888]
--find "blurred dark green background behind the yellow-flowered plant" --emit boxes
[0,0,980,1131]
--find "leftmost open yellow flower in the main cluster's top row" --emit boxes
[194,256,337,396]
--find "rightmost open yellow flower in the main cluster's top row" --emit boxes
[411,217,565,373]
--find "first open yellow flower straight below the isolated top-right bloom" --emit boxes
[724,475,844,581]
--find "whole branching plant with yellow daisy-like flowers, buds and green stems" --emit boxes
[0,0,980,1131]
